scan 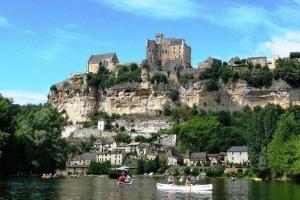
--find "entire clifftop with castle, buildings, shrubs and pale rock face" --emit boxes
[48,33,300,123]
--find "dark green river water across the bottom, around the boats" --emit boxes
[0,177,300,200]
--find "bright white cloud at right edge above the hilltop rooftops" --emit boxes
[258,31,300,57]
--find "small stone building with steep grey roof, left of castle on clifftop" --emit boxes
[87,53,119,73]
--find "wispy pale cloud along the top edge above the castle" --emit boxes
[97,0,200,19]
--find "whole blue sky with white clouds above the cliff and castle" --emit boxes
[0,0,300,104]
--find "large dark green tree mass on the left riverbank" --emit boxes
[0,96,68,175]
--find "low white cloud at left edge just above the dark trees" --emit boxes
[0,90,47,105]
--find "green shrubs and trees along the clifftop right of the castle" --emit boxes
[199,52,300,88]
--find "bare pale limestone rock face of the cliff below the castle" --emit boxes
[48,74,300,123]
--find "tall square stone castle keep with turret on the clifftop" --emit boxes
[146,33,191,72]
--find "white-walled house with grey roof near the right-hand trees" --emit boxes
[227,146,249,165]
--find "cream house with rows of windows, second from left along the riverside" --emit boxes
[96,149,126,166]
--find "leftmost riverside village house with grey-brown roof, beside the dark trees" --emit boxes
[66,153,96,174]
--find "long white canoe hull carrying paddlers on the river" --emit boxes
[156,183,213,192]
